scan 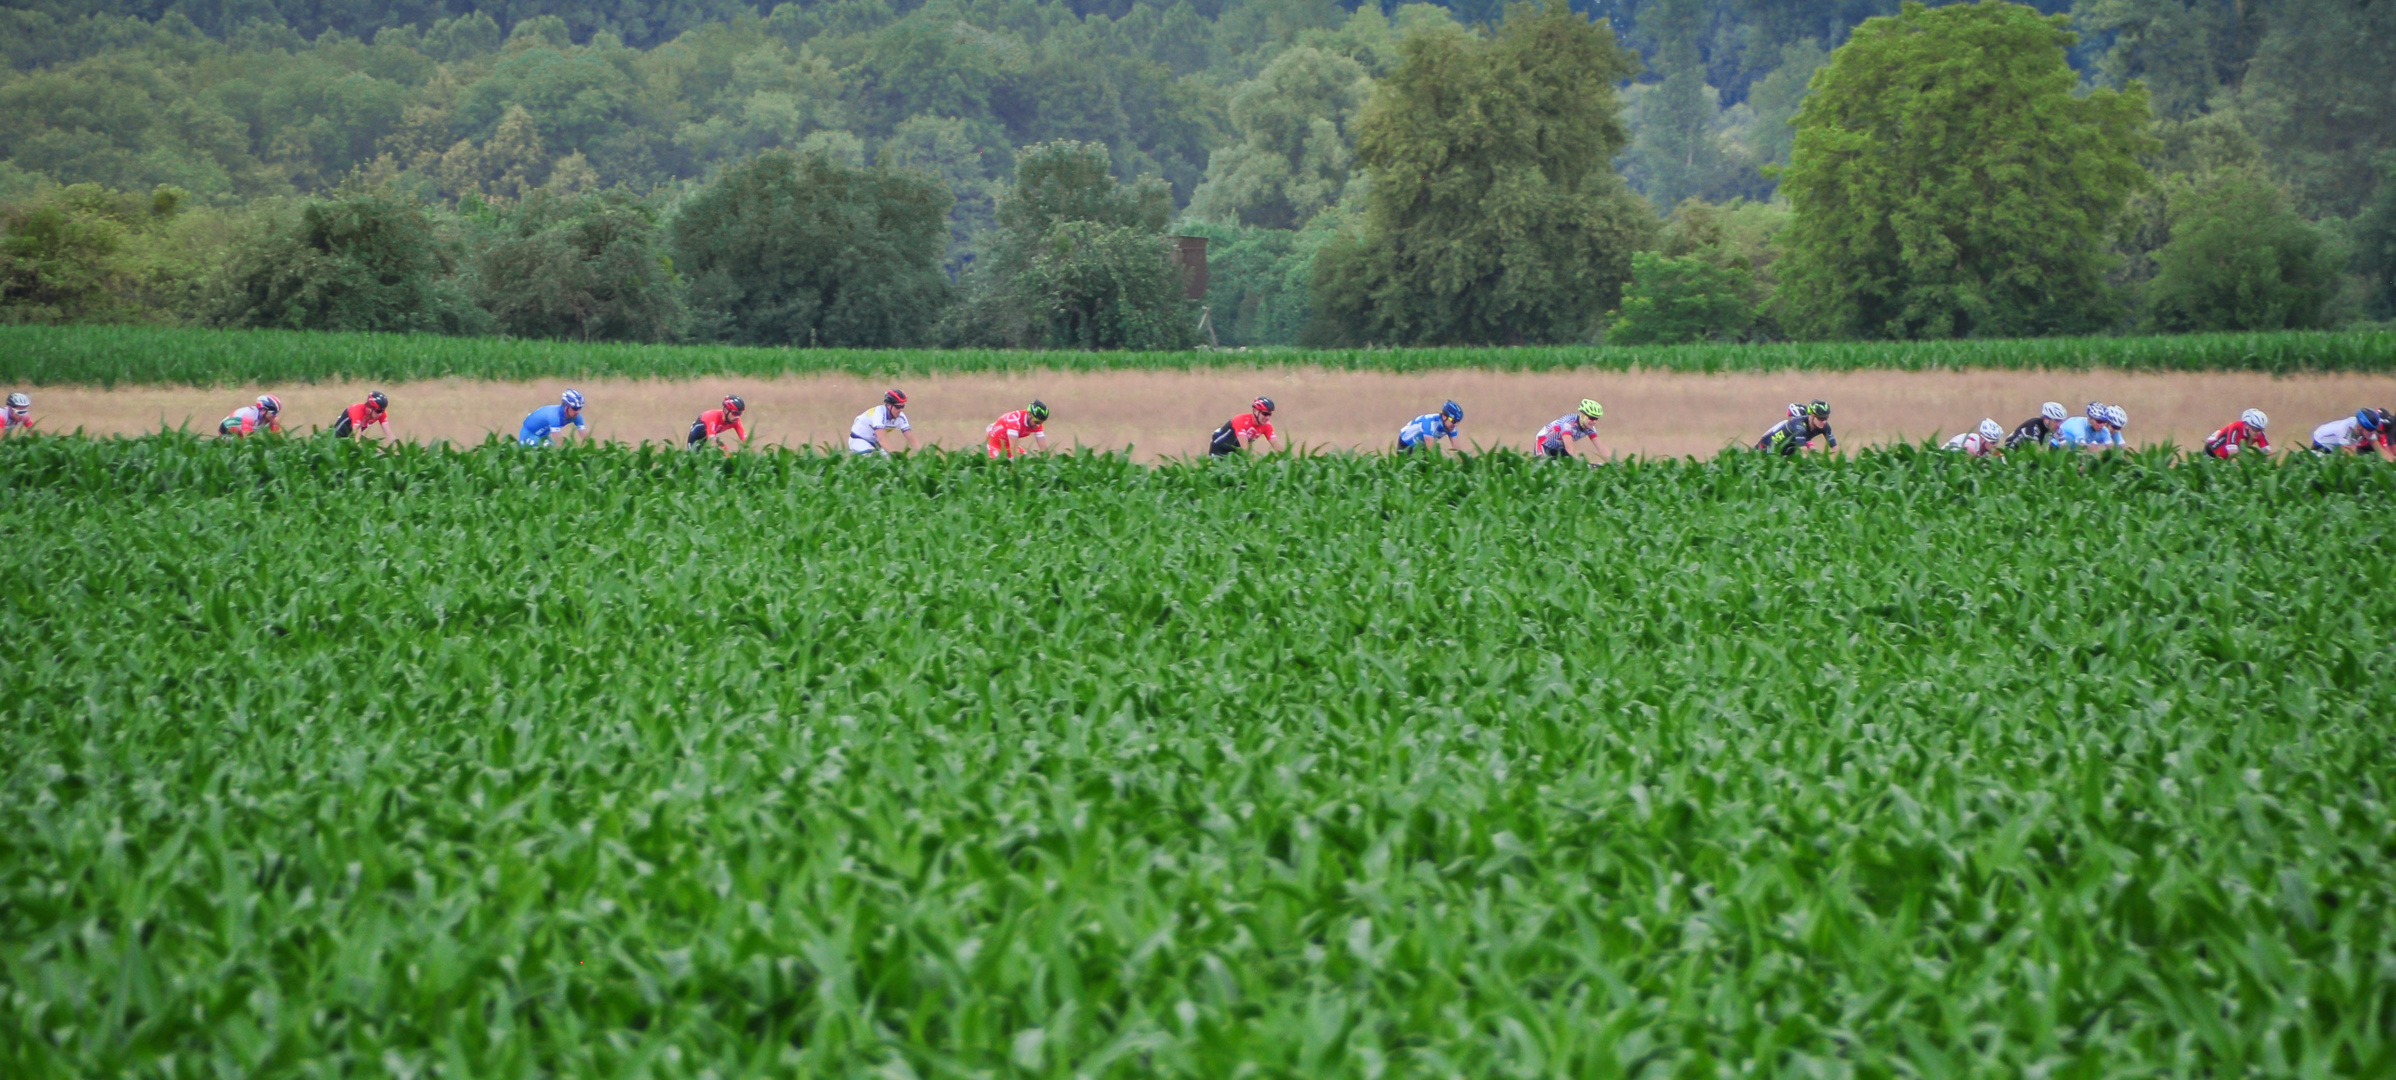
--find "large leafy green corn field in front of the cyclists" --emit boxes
[0,435,2396,1080]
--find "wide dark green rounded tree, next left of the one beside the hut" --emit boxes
[671,153,949,347]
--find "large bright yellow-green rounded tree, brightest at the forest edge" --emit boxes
[1780,2,2147,338]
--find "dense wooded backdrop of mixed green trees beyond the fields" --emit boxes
[0,0,2396,347]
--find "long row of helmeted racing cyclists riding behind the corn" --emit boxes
[0,388,2396,465]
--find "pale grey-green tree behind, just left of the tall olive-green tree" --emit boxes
[1191,45,1373,230]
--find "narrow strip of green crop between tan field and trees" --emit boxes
[0,326,2396,386]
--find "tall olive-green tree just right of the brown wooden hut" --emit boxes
[1313,5,1653,345]
